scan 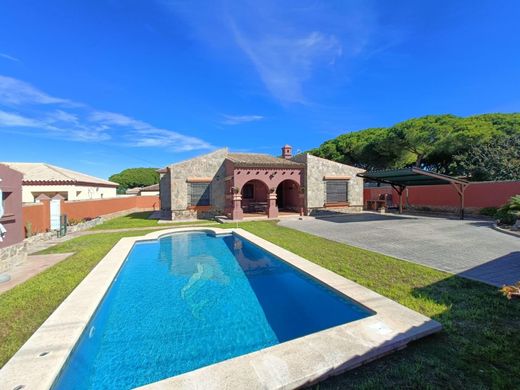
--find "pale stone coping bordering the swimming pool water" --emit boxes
[0,227,442,390]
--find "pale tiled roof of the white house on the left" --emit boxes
[1,162,119,187]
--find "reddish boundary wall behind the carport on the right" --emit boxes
[364,181,520,208]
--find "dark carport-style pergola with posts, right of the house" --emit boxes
[358,167,470,219]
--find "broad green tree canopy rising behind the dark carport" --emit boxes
[310,114,520,180]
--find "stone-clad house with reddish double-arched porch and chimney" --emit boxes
[159,145,363,220]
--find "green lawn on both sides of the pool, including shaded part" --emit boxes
[0,222,520,389]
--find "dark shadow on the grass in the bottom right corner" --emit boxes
[312,275,520,390]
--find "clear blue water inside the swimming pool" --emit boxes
[54,232,373,390]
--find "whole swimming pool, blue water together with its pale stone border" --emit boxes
[0,227,442,390]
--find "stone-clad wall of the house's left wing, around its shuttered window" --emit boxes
[168,148,228,219]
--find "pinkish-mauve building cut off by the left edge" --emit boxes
[0,164,24,250]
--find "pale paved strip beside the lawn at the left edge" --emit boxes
[0,253,74,294]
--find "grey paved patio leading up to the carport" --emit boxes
[280,213,520,286]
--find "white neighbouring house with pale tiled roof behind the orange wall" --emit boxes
[0,162,118,203]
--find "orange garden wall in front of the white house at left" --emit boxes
[22,196,160,234]
